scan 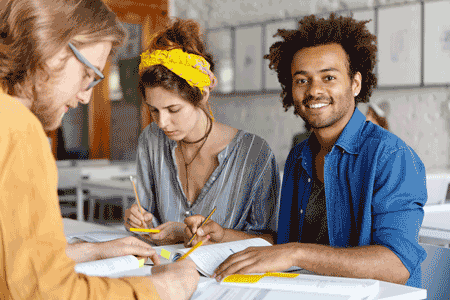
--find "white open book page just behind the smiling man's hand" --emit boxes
[174,238,272,276]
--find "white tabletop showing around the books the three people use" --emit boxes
[63,219,427,300]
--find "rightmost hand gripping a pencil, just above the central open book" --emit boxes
[184,215,225,247]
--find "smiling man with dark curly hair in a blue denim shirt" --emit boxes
[215,14,427,287]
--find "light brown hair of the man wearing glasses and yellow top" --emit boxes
[0,0,126,99]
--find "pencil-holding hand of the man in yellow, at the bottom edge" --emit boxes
[151,259,200,300]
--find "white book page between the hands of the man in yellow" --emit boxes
[75,255,139,276]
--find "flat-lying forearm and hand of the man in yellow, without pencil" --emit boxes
[66,236,160,265]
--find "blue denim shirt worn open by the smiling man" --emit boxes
[277,109,427,287]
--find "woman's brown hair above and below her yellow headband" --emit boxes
[139,18,214,106]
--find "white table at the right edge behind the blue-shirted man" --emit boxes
[419,204,450,246]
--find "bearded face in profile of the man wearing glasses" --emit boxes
[30,42,112,130]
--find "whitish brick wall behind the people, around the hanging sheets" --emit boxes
[171,0,450,170]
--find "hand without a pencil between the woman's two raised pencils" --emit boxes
[141,222,186,245]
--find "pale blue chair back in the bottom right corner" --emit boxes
[420,244,450,300]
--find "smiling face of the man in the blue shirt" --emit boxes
[291,44,361,132]
